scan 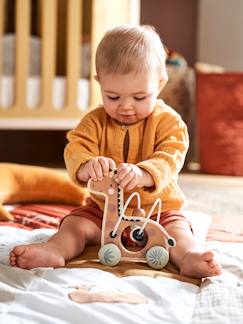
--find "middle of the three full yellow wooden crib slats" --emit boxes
[41,0,57,112]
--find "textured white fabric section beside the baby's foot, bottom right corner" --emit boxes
[191,242,243,324]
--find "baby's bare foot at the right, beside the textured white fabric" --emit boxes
[180,251,222,278]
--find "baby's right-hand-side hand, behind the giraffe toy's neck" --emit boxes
[116,163,143,190]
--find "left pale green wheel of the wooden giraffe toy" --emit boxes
[98,243,121,267]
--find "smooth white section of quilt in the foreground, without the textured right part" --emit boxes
[0,227,199,324]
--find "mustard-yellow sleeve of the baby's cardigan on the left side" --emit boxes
[64,114,101,186]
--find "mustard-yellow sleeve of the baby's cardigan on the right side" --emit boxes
[137,115,189,194]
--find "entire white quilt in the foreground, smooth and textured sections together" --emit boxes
[0,227,243,324]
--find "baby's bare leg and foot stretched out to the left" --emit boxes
[10,216,101,269]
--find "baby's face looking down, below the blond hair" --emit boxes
[97,72,166,125]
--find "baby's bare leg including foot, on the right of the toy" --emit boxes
[165,220,221,278]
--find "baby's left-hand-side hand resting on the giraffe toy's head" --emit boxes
[77,156,116,182]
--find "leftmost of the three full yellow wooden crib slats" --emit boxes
[15,0,30,110]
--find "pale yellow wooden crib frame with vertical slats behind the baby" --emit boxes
[0,0,139,130]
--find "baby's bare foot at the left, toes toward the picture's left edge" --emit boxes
[9,243,65,269]
